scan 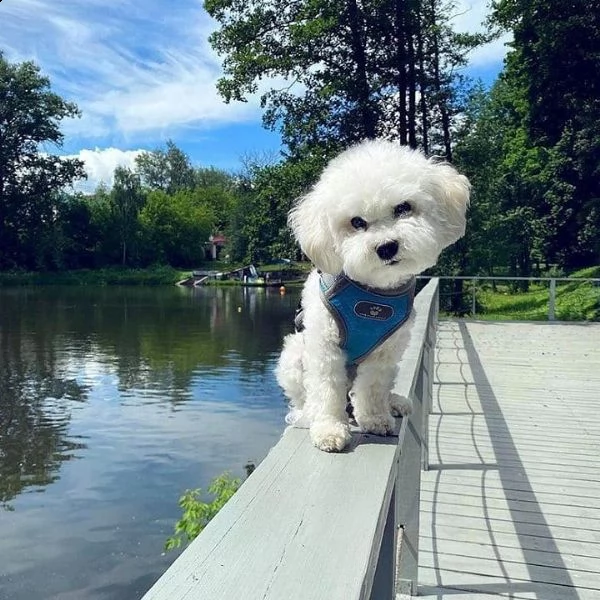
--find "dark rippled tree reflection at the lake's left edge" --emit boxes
[0,293,86,508]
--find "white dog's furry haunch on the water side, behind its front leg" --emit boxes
[275,333,306,425]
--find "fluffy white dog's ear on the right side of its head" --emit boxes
[434,163,471,246]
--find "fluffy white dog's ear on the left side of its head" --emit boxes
[288,189,343,274]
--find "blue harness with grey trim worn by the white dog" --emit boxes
[296,273,415,366]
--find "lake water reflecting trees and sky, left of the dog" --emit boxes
[0,287,298,600]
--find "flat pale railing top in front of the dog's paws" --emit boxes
[144,429,404,600]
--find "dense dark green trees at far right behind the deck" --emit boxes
[455,0,600,278]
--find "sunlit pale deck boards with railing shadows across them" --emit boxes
[419,321,600,600]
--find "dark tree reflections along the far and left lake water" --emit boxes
[0,288,297,504]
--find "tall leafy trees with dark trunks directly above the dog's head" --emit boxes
[205,0,481,158]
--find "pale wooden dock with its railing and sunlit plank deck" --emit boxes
[143,279,600,600]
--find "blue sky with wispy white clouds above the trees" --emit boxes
[0,0,506,188]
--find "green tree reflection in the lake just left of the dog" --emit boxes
[96,287,297,394]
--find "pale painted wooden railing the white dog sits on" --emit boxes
[143,279,438,600]
